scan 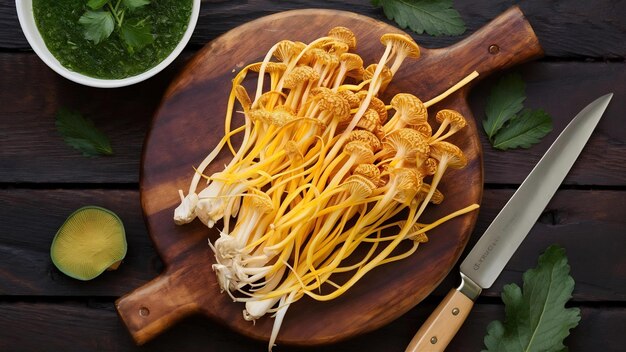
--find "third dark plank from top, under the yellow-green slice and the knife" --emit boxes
[0,189,626,302]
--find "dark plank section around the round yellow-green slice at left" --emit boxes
[0,189,162,297]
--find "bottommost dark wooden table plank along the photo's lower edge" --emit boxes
[0,300,626,352]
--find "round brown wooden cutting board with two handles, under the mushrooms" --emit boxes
[116,7,542,345]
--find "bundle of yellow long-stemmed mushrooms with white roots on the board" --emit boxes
[174,27,478,349]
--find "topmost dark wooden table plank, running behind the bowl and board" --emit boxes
[0,0,626,59]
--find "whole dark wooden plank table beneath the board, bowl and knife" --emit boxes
[0,0,626,351]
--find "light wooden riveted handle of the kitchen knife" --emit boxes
[406,289,474,352]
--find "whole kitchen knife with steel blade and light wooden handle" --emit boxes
[406,93,613,352]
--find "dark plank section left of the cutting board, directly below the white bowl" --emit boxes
[0,54,189,183]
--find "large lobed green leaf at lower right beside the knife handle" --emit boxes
[483,245,580,352]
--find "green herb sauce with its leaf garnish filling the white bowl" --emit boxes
[33,0,193,79]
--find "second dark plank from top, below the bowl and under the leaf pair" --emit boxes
[0,51,626,186]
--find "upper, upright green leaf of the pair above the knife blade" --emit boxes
[483,74,526,141]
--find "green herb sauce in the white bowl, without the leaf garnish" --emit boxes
[33,0,192,79]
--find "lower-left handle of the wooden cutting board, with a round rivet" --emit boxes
[115,267,198,345]
